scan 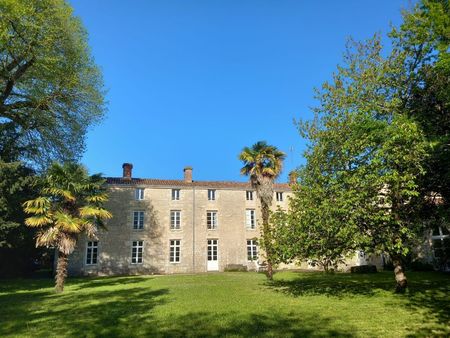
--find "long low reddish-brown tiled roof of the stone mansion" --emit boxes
[106,177,291,191]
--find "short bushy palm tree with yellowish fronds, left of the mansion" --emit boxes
[24,163,112,292]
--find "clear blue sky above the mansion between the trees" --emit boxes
[70,0,411,181]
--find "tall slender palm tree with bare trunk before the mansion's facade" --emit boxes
[239,141,286,279]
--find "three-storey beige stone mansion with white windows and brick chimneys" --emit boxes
[69,163,291,275]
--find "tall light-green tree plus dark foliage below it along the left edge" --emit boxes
[0,0,105,275]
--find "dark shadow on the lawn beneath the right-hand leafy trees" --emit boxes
[266,272,450,337]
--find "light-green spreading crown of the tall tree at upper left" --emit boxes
[0,0,104,167]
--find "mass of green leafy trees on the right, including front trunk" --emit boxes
[272,0,450,289]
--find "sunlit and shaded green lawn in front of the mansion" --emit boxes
[0,272,450,337]
